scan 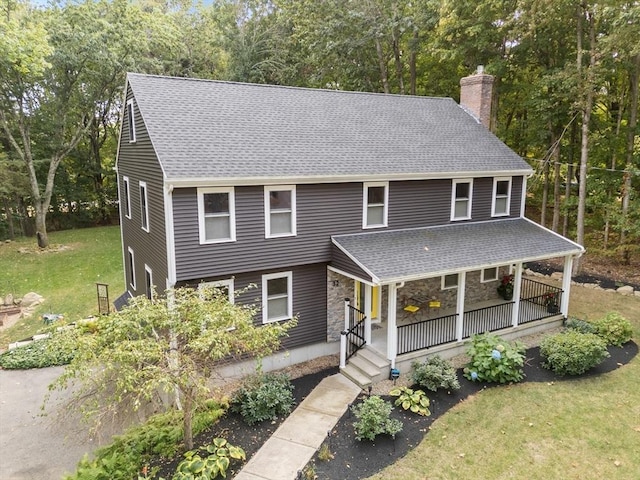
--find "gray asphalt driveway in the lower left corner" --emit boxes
[0,367,108,480]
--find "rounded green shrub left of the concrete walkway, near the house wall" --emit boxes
[231,373,294,425]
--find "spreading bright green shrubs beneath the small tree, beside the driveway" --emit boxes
[64,401,224,480]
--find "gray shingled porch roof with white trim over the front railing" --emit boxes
[332,218,584,284]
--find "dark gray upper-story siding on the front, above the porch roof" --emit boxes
[173,177,521,281]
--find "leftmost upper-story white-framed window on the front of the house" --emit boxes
[198,187,236,243]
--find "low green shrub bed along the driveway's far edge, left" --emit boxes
[0,336,74,370]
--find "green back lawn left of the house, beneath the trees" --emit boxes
[0,226,124,349]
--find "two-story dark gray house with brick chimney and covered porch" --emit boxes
[117,73,583,384]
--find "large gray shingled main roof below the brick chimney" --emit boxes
[128,73,531,180]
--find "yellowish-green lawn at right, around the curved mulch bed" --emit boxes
[371,287,640,480]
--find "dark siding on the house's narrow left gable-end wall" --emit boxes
[118,86,167,295]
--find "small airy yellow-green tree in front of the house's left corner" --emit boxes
[50,288,295,450]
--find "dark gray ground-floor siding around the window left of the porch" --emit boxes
[181,264,327,348]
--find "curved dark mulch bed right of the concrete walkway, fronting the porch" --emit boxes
[312,342,638,480]
